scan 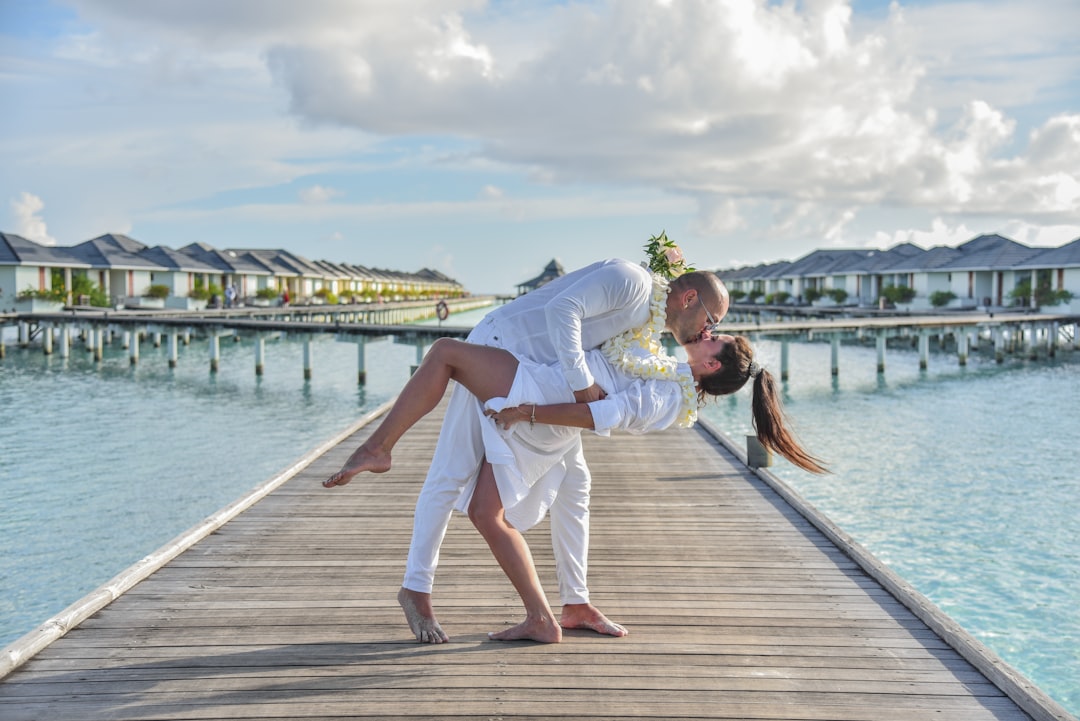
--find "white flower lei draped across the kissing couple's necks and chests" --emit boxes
[600,273,698,428]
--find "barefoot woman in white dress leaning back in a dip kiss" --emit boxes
[323,336,824,642]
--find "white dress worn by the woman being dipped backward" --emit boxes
[456,350,687,531]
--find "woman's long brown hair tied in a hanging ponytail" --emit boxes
[698,336,826,473]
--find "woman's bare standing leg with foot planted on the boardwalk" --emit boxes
[469,461,563,643]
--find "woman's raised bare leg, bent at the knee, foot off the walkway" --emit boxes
[323,338,517,488]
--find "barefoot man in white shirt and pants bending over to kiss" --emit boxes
[325,259,728,643]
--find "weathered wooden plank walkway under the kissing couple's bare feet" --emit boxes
[0,397,1070,721]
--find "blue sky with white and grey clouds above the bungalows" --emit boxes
[0,0,1080,293]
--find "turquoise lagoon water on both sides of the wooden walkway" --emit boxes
[0,312,1080,713]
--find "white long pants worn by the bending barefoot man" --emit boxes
[402,319,592,606]
